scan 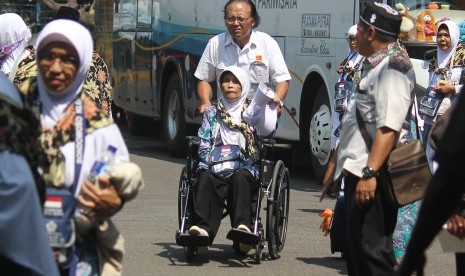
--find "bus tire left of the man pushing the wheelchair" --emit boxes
[163,73,186,157]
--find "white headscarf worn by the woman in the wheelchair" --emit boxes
[218,66,250,145]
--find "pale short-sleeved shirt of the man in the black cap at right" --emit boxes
[336,43,415,177]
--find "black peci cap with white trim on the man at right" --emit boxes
[360,2,402,36]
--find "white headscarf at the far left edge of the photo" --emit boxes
[0,13,31,74]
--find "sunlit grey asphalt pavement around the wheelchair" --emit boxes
[113,129,455,276]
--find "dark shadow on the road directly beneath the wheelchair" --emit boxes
[154,243,266,267]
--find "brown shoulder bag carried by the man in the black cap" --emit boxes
[356,103,431,207]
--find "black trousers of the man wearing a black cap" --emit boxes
[344,174,397,276]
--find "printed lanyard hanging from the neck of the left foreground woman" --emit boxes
[72,98,86,194]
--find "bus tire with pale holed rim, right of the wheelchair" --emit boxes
[305,85,332,181]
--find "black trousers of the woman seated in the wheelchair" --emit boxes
[193,169,258,242]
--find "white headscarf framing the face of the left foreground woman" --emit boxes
[37,19,93,128]
